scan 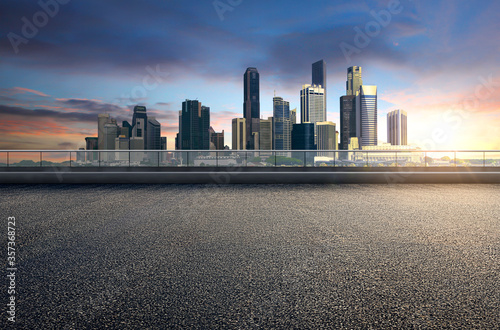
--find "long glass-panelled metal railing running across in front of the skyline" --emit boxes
[0,149,500,167]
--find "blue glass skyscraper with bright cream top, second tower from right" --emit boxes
[356,85,378,147]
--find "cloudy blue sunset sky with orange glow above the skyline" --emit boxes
[0,0,500,150]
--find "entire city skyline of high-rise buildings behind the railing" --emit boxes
[86,60,409,159]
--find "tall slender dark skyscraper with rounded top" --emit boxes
[243,68,260,150]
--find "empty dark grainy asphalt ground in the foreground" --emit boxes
[0,185,500,329]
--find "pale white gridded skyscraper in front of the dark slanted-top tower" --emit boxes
[300,85,326,141]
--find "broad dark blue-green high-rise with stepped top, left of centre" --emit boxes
[178,100,210,150]
